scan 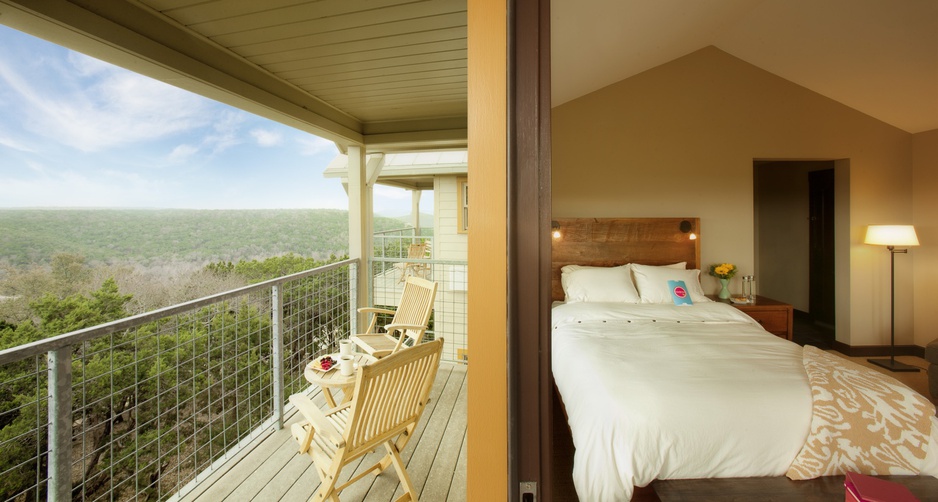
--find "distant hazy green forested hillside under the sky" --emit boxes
[0,209,403,266]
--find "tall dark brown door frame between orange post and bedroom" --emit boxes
[508,0,553,502]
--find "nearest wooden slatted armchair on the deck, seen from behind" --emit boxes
[290,339,443,502]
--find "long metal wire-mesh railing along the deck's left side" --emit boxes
[0,259,361,500]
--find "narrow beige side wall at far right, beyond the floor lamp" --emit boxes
[911,129,938,346]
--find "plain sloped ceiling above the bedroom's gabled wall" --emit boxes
[551,0,938,133]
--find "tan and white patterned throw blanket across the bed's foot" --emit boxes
[786,346,935,480]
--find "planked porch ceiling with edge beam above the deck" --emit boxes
[0,0,467,151]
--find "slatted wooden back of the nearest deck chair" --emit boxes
[345,339,443,457]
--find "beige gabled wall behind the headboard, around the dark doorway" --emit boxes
[552,47,912,345]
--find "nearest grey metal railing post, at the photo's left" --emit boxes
[48,346,72,501]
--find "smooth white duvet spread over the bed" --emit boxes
[552,302,938,501]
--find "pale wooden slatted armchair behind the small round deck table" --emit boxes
[350,277,437,358]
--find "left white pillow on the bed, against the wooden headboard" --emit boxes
[560,265,641,303]
